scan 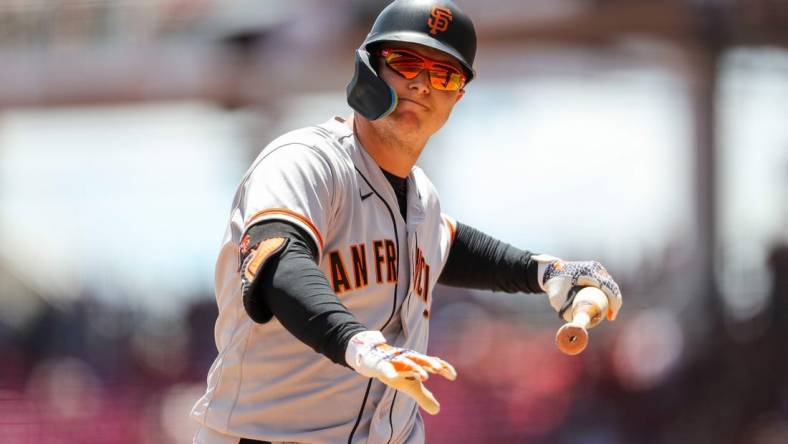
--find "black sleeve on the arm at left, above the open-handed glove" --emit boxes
[244,221,369,366]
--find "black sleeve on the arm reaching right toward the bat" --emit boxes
[438,223,542,293]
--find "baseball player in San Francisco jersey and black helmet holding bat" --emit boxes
[191,0,621,444]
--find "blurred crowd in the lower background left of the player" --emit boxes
[0,282,216,444]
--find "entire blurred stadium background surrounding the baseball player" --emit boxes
[0,0,788,444]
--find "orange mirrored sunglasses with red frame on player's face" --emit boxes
[380,49,465,91]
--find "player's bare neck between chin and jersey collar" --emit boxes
[346,116,427,177]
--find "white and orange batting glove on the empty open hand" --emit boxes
[345,330,457,415]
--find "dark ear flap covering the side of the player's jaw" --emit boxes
[346,48,397,120]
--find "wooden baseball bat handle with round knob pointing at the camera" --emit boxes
[555,287,607,355]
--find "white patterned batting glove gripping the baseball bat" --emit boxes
[532,254,623,322]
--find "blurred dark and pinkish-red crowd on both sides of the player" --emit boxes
[0,246,788,444]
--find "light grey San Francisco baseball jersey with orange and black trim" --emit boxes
[192,117,455,443]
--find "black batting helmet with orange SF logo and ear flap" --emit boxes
[347,0,476,120]
